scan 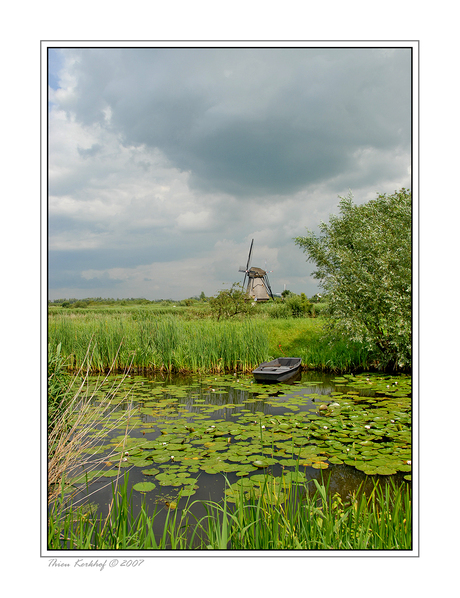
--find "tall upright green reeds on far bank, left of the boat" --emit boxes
[48,316,268,371]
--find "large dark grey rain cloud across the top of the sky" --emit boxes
[55,49,410,197]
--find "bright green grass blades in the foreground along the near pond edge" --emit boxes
[48,477,412,550]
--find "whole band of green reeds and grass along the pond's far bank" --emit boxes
[48,310,372,373]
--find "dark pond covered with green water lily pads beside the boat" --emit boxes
[63,372,412,522]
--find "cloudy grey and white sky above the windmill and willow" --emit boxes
[48,47,411,300]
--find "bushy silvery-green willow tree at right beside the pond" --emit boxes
[295,188,412,367]
